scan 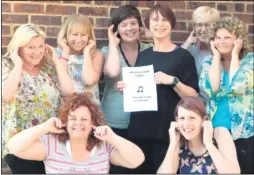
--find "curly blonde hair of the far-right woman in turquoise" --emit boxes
[210,17,250,59]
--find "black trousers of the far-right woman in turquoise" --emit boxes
[234,136,254,174]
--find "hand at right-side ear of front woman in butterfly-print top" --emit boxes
[202,120,213,145]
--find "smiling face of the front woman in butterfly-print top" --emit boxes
[177,106,203,140]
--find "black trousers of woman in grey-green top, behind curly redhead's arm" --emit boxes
[109,128,133,174]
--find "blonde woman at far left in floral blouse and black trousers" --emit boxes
[2,24,74,174]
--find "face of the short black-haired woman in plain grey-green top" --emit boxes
[118,17,140,42]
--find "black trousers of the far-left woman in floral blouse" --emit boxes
[4,154,46,174]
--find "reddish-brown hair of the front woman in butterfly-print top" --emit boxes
[174,96,206,118]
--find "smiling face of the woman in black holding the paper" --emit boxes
[149,12,172,39]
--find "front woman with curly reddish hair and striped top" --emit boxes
[8,93,144,174]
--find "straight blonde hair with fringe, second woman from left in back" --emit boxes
[57,14,96,47]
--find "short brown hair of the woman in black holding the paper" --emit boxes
[144,4,176,29]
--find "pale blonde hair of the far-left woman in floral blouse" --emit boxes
[4,23,46,57]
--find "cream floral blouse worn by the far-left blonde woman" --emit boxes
[2,58,60,157]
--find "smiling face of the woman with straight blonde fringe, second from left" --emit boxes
[67,24,89,53]
